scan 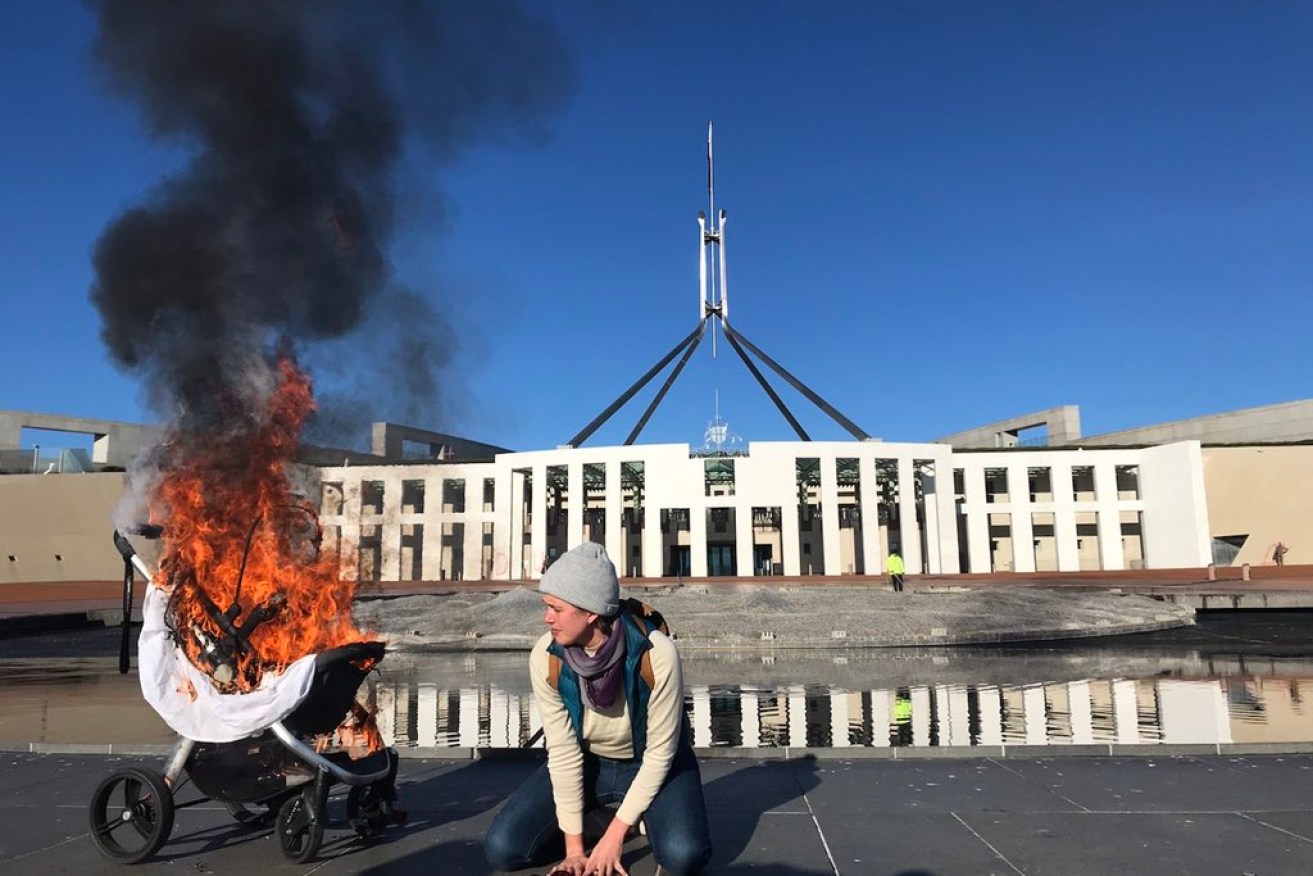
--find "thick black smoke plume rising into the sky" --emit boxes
[89,0,572,446]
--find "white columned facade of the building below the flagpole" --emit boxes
[320,441,1211,580]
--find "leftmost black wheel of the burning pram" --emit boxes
[89,767,173,864]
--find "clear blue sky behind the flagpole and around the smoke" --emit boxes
[0,0,1313,449]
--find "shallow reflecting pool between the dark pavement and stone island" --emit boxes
[0,612,1313,749]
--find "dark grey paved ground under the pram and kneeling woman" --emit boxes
[0,754,1313,876]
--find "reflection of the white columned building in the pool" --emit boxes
[376,678,1313,749]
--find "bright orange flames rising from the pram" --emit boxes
[151,357,368,691]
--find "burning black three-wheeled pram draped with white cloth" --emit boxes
[91,532,404,864]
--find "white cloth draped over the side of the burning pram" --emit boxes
[137,584,315,742]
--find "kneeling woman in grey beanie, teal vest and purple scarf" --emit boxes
[484,541,712,876]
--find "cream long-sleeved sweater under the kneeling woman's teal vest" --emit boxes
[529,632,684,834]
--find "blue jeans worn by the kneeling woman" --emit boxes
[483,745,712,876]
